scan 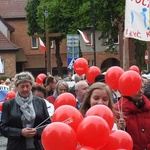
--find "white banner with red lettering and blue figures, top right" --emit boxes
[124,0,150,41]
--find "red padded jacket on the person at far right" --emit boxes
[115,96,150,150]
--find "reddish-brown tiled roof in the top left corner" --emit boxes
[0,0,27,18]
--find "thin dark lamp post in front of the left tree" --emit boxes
[43,9,48,75]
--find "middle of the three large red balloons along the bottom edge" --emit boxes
[77,116,110,149]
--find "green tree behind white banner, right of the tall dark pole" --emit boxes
[95,0,147,69]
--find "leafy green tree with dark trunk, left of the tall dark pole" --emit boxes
[26,0,88,76]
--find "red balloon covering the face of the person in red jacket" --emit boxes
[119,71,142,96]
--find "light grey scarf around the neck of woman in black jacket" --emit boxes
[15,92,35,123]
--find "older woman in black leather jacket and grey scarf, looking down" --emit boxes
[1,72,51,150]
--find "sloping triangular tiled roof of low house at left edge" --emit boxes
[0,31,19,50]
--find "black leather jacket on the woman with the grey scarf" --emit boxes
[1,97,51,150]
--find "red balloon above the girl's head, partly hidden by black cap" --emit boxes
[86,66,102,83]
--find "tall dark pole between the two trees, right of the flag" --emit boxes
[91,0,96,66]
